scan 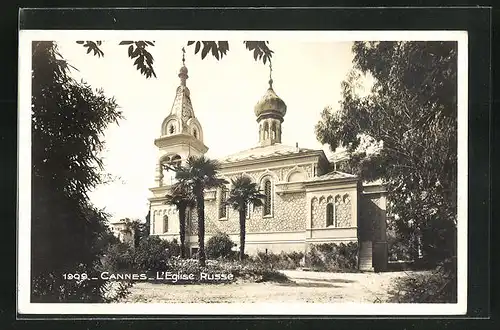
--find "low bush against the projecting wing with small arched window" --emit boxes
[306,242,358,271]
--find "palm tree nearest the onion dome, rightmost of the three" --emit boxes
[226,176,266,261]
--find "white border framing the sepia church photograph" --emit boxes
[17,30,468,316]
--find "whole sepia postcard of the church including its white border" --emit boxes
[18,30,468,315]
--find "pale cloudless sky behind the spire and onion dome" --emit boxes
[58,40,368,220]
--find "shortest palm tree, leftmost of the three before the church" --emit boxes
[165,182,196,259]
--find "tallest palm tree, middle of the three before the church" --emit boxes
[174,155,227,266]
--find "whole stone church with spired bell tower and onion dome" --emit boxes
[149,59,387,270]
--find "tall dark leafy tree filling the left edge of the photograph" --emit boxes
[31,42,121,302]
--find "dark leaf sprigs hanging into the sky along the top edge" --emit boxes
[77,40,273,78]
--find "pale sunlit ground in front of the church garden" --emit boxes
[118,270,430,303]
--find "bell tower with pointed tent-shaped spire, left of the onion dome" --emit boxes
[154,48,208,187]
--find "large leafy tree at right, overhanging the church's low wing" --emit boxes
[316,41,457,261]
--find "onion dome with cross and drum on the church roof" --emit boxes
[254,62,286,147]
